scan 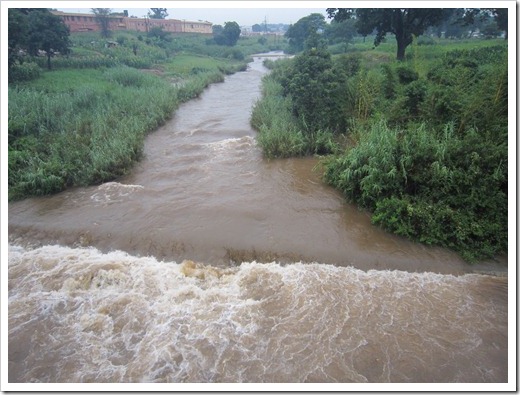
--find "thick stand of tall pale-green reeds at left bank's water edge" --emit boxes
[8,68,179,199]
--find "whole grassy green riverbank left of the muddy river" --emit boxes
[8,32,282,200]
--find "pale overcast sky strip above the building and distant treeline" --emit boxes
[57,1,326,26]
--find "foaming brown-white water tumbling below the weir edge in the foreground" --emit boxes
[8,245,507,382]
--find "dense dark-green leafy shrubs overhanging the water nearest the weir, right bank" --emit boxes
[325,121,507,261]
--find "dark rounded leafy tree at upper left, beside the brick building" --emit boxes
[27,8,71,70]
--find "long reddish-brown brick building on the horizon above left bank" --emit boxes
[51,11,213,34]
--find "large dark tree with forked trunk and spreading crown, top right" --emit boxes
[327,8,446,60]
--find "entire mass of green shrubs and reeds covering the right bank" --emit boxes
[252,10,508,262]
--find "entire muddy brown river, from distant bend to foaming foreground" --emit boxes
[8,56,508,382]
